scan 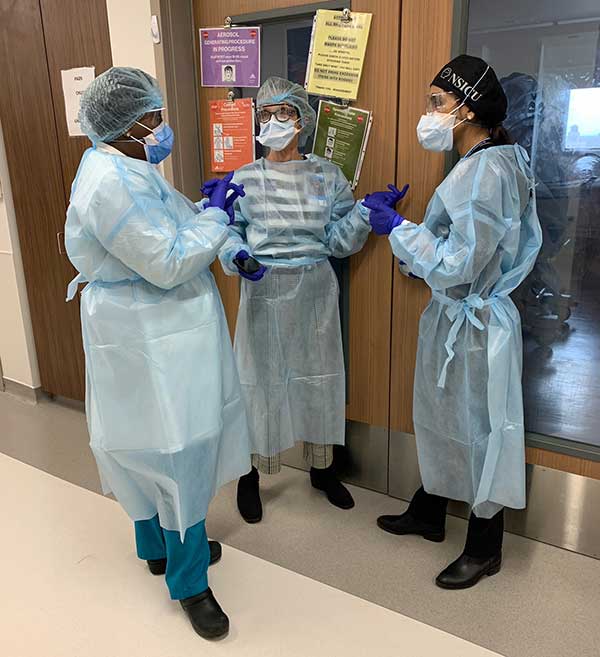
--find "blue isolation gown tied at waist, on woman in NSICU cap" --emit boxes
[390,146,542,518]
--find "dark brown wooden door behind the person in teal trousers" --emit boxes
[0,0,111,399]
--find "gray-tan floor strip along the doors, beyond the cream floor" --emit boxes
[0,393,600,657]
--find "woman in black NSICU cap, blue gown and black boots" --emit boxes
[364,55,542,589]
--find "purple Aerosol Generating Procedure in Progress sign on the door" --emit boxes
[200,27,260,87]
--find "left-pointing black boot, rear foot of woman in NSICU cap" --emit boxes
[377,487,448,543]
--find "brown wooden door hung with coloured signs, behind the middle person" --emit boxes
[194,0,401,430]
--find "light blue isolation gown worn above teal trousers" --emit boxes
[65,144,250,537]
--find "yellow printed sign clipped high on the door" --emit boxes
[304,10,372,100]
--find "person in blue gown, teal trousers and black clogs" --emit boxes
[65,67,250,638]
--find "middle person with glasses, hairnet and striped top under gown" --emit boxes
[213,77,378,523]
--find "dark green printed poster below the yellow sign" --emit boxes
[313,100,373,189]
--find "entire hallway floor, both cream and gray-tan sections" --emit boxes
[0,394,600,657]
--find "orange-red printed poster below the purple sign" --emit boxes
[209,98,254,172]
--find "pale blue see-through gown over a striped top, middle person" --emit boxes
[220,155,370,456]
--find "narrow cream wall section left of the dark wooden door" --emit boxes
[0,120,40,388]
